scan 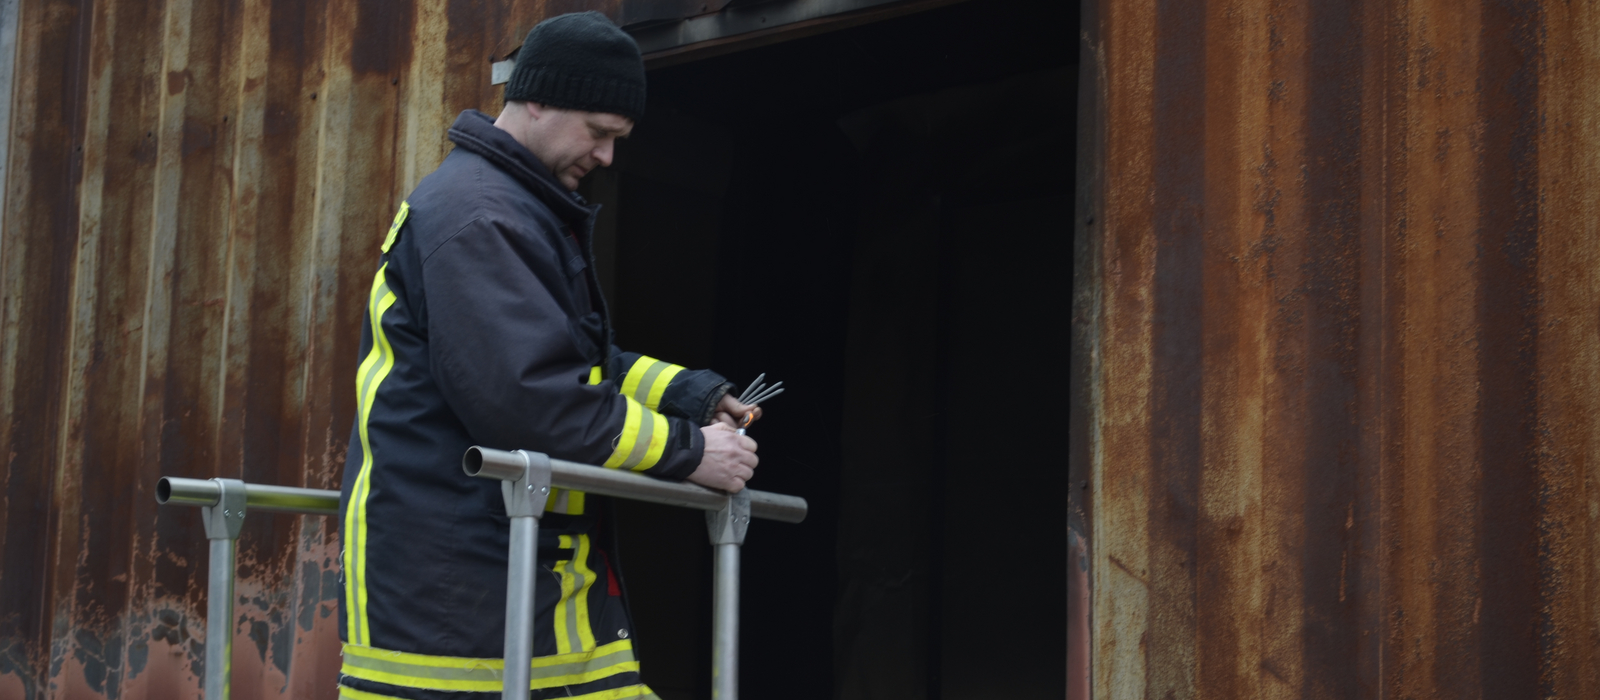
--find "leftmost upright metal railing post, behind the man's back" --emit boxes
[200,479,245,700]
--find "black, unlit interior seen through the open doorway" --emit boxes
[586,0,1078,700]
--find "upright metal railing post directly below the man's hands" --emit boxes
[706,491,750,700]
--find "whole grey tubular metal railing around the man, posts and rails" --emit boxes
[155,447,806,700]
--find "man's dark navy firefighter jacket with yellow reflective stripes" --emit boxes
[339,112,728,692]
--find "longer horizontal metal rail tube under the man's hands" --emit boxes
[462,447,806,523]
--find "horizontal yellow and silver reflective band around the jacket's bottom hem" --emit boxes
[339,639,638,692]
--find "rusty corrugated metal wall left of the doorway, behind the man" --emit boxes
[0,0,614,700]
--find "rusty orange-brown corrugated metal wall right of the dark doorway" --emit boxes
[1077,0,1600,700]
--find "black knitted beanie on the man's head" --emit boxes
[506,13,645,121]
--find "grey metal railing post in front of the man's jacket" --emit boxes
[501,451,550,700]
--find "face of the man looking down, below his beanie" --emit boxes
[523,102,634,190]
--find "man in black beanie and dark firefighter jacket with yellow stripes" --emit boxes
[339,13,758,700]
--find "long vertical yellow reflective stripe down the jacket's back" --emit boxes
[342,262,395,644]
